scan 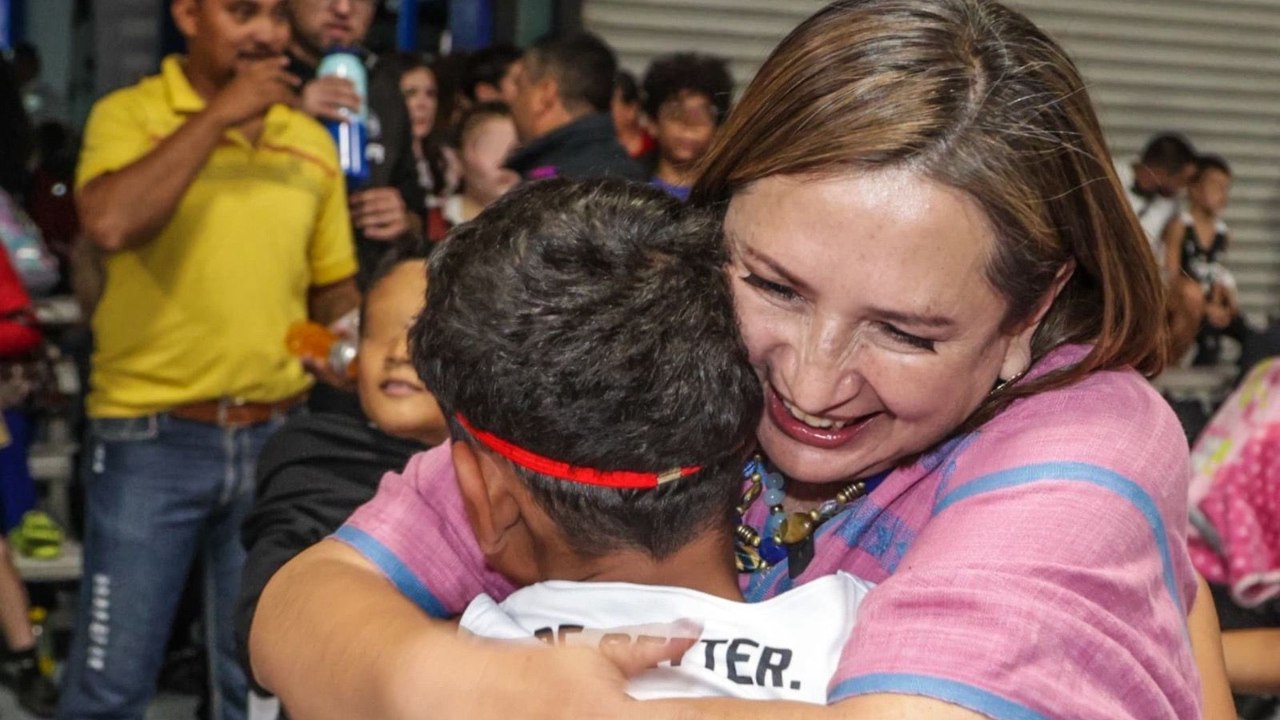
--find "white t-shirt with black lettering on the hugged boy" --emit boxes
[461,573,872,705]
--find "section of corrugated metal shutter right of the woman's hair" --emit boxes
[1015,0,1280,314]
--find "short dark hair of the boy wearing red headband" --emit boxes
[410,178,763,559]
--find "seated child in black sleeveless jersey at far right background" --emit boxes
[1164,155,1244,365]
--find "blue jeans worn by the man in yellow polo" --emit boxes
[58,414,284,720]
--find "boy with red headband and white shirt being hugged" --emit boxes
[409,179,867,703]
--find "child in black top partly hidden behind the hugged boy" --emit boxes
[236,243,448,676]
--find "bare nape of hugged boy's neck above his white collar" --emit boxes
[545,532,742,601]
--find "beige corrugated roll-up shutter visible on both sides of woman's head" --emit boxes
[582,0,1280,314]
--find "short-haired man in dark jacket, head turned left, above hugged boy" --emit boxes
[507,32,645,181]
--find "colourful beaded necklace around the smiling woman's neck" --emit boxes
[735,455,888,578]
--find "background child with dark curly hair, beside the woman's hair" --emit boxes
[644,53,733,200]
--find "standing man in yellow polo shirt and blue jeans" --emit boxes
[59,0,358,720]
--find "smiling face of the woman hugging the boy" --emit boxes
[724,170,1030,483]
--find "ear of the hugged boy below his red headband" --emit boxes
[451,441,521,556]
